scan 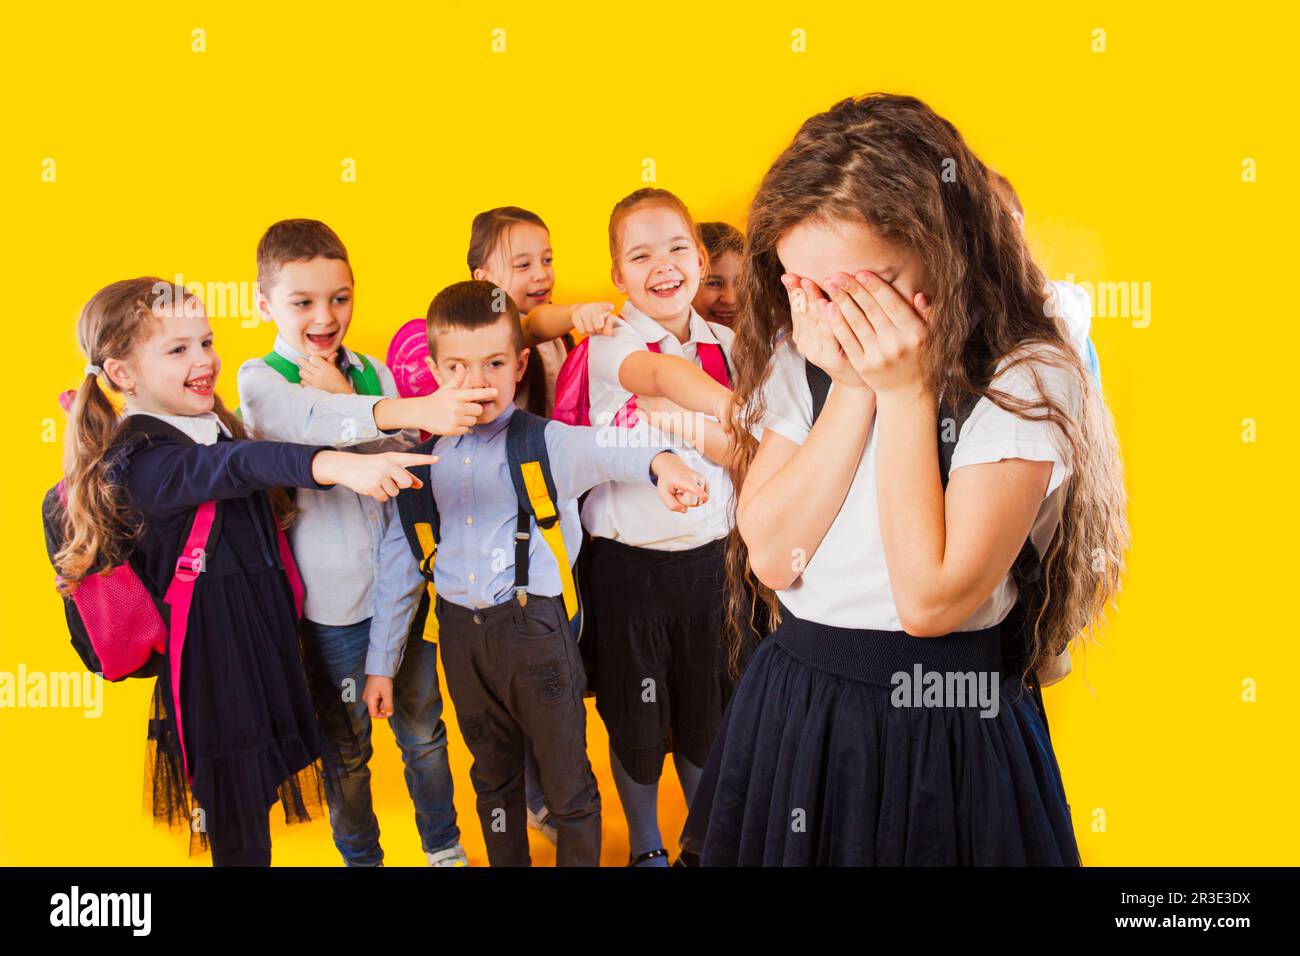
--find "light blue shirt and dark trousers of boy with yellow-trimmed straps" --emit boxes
[367,406,667,866]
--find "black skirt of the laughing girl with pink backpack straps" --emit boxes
[582,537,759,784]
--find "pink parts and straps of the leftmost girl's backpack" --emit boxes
[43,481,303,777]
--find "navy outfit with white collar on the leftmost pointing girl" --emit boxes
[109,414,335,865]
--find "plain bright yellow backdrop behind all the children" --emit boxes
[0,3,1300,865]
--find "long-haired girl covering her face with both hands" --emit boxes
[683,95,1127,865]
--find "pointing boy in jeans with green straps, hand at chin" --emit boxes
[239,220,495,866]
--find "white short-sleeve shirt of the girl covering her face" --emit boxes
[763,336,1080,631]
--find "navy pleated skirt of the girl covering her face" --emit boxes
[683,607,1080,866]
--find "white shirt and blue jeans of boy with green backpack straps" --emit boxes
[239,336,460,866]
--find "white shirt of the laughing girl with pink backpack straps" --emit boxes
[582,302,735,551]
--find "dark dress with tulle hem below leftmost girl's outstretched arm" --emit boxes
[146,499,330,855]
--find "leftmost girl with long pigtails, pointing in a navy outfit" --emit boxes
[55,277,430,866]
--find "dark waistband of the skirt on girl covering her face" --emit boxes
[770,604,1002,685]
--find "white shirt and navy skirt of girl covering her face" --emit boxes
[683,336,1079,865]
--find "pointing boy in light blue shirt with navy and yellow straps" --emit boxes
[365,281,707,866]
